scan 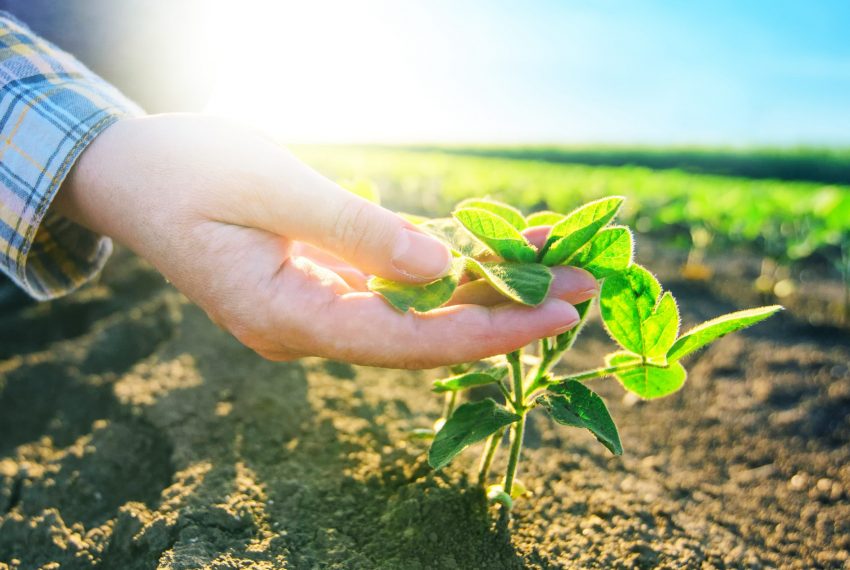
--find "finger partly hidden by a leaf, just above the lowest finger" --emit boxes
[448,267,599,307]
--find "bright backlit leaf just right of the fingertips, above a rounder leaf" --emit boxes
[599,265,679,359]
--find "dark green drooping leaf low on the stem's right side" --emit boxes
[538,380,623,455]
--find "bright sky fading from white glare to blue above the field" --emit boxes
[205,0,850,146]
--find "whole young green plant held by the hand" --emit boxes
[369,196,781,508]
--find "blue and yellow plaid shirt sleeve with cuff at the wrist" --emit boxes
[0,12,142,300]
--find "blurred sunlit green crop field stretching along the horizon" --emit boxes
[293,146,850,270]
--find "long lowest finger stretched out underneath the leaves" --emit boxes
[263,263,579,368]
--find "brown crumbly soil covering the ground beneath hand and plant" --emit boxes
[0,245,850,570]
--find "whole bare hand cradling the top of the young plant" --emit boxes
[52,115,596,368]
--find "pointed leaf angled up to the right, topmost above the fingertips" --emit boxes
[541,196,624,266]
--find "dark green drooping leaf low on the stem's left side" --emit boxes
[428,398,520,469]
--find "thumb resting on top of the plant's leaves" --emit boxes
[250,156,451,282]
